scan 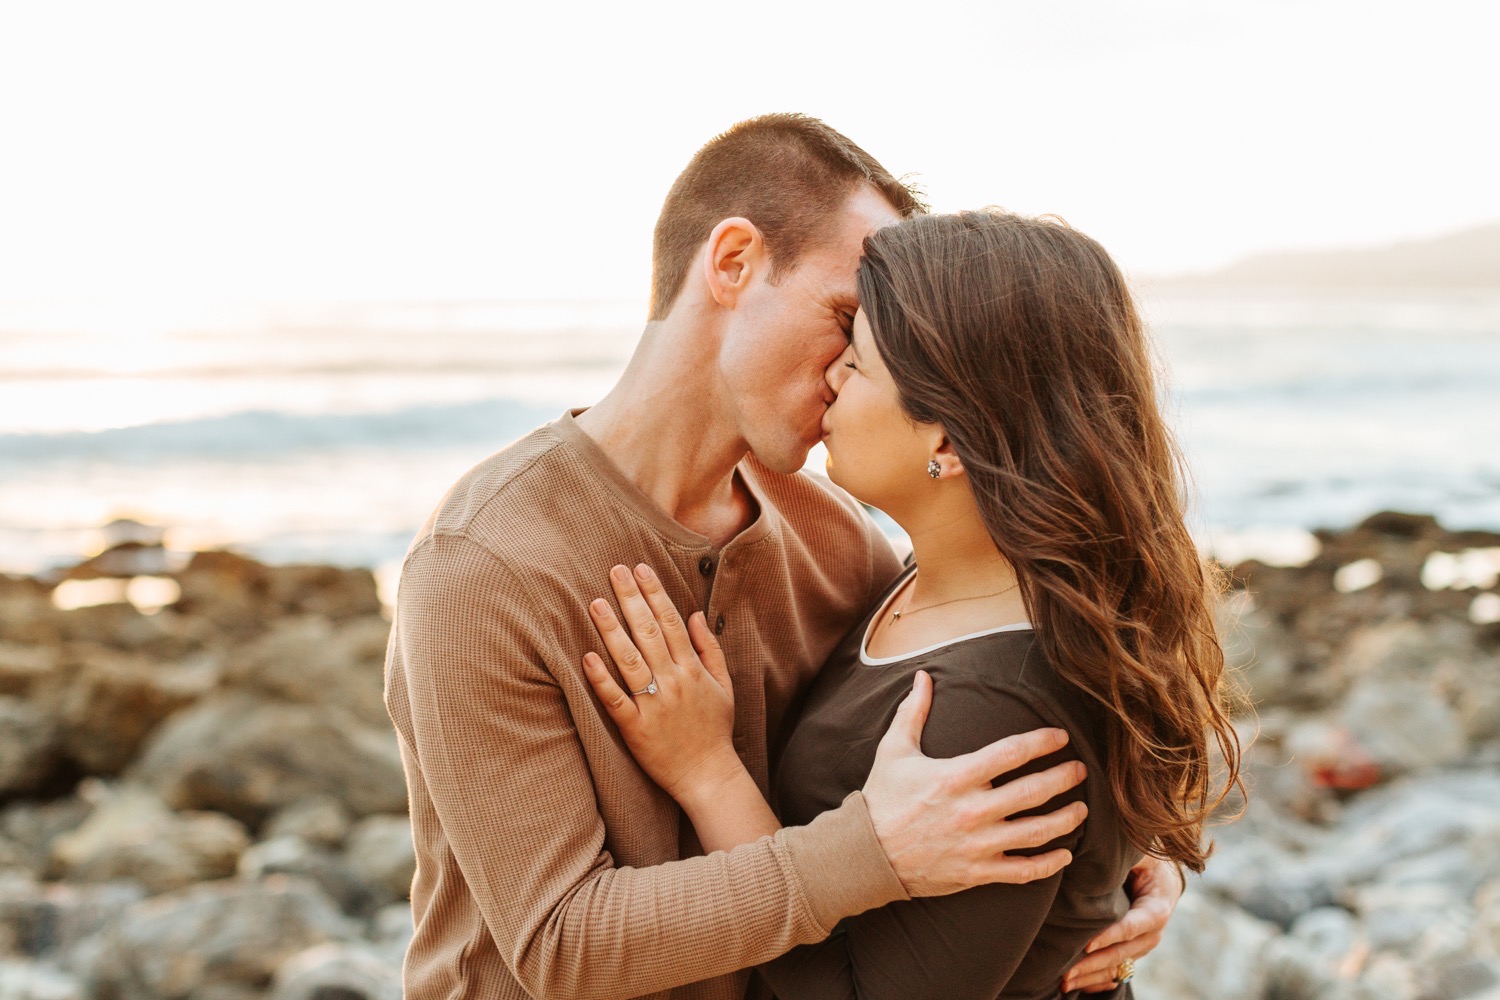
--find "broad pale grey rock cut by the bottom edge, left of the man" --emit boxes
[89,877,359,1000]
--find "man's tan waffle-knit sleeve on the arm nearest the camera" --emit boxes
[387,535,905,999]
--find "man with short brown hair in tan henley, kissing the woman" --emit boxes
[386,115,1176,1000]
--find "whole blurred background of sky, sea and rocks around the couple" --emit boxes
[0,0,1500,1000]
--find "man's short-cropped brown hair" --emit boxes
[650,114,926,319]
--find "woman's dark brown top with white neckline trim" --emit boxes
[761,563,1140,1000]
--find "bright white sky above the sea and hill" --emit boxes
[0,0,1500,303]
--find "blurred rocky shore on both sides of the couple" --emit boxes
[0,514,1500,1000]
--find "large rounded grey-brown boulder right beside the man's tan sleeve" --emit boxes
[128,693,407,828]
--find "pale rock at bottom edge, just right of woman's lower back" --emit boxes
[1134,892,1278,1000]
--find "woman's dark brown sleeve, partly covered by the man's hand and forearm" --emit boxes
[759,689,1082,1000]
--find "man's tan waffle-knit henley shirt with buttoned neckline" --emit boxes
[386,415,906,1000]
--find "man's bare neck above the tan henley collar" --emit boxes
[578,322,756,546]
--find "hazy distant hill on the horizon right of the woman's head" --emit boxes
[1143,223,1500,291]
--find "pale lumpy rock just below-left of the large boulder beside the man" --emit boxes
[53,787,251,892]
